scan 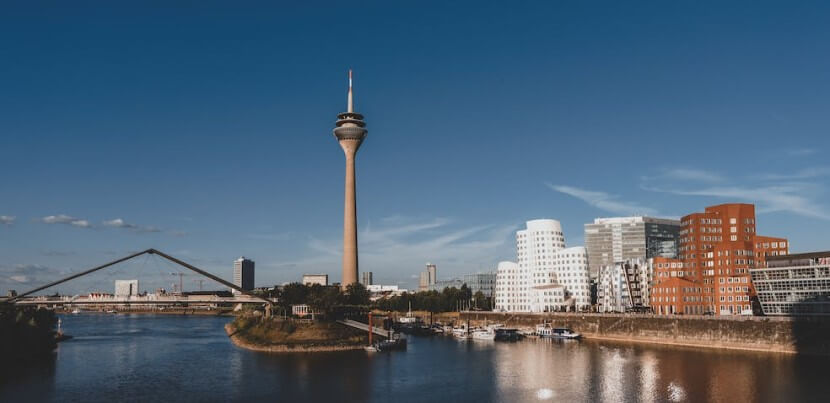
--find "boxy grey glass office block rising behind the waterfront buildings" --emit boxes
[585,216,680,278]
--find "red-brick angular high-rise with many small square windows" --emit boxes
[652,203,789,315]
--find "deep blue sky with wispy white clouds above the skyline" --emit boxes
[0,1,830,293]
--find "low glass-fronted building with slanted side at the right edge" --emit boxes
[750,251,830,315]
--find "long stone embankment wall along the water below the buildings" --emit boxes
[460,312,830,355]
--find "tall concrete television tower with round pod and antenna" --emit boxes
[334,70,368,289]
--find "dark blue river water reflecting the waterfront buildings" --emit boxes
[0,314,830,403]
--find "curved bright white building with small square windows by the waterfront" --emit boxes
[495,219,591,312]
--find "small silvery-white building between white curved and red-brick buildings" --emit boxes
[597,258,653,312]
